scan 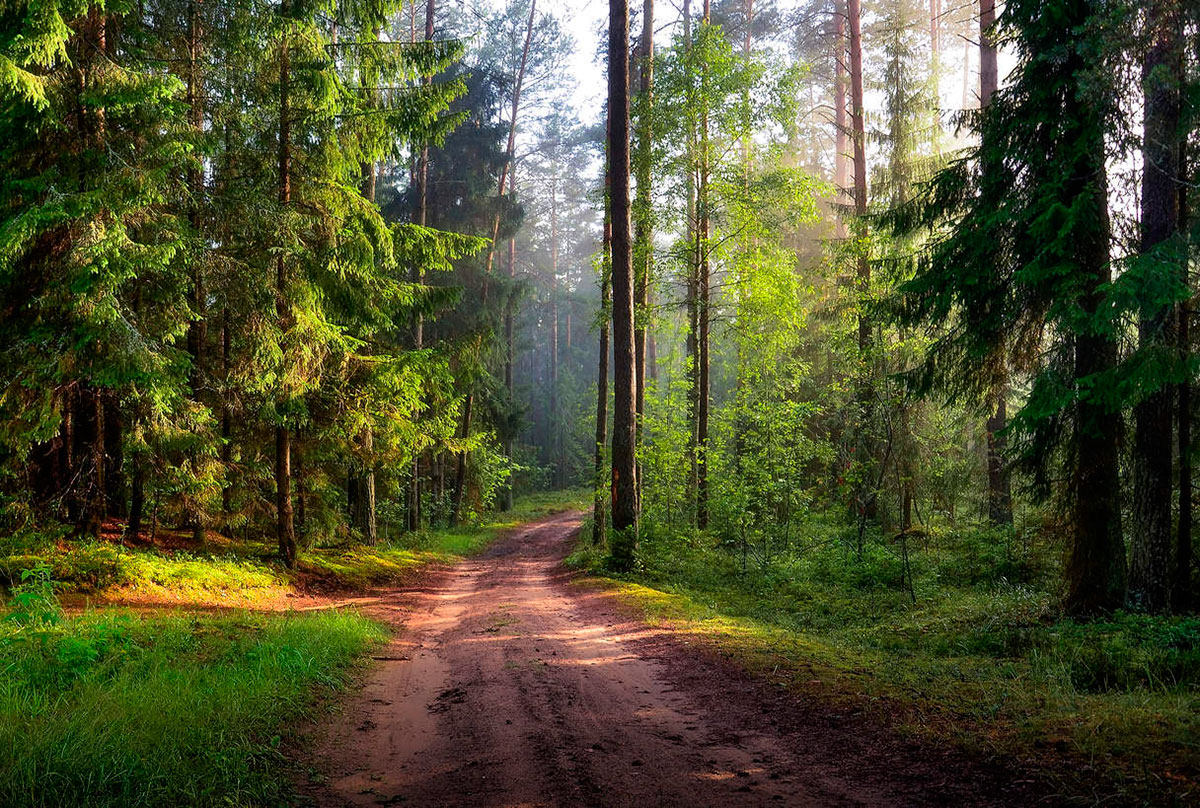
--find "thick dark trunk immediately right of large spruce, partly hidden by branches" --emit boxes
[1127,0,1183,612]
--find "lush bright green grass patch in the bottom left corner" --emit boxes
[0,611,385,807]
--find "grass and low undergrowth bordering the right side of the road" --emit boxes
[570,520,1200,804]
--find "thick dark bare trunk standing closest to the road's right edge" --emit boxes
[608,0,638,557]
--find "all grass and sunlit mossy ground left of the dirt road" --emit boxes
[0,492,589,807]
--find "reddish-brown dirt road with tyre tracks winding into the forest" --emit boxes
[304,513,1030,806]
